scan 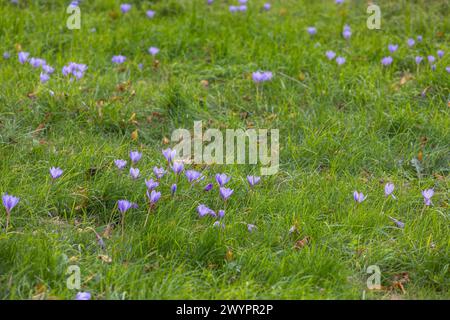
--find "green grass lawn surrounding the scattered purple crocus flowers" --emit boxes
[0,0,450,299]
